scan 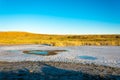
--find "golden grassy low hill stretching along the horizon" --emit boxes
[0,32,120,46]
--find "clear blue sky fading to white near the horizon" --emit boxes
[0,0,120,34]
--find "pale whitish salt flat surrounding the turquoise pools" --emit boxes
[0,45,120,67]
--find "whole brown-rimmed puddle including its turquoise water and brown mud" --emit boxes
[23,50,66,56]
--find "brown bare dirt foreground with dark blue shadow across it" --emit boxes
[0,62,120,80]
